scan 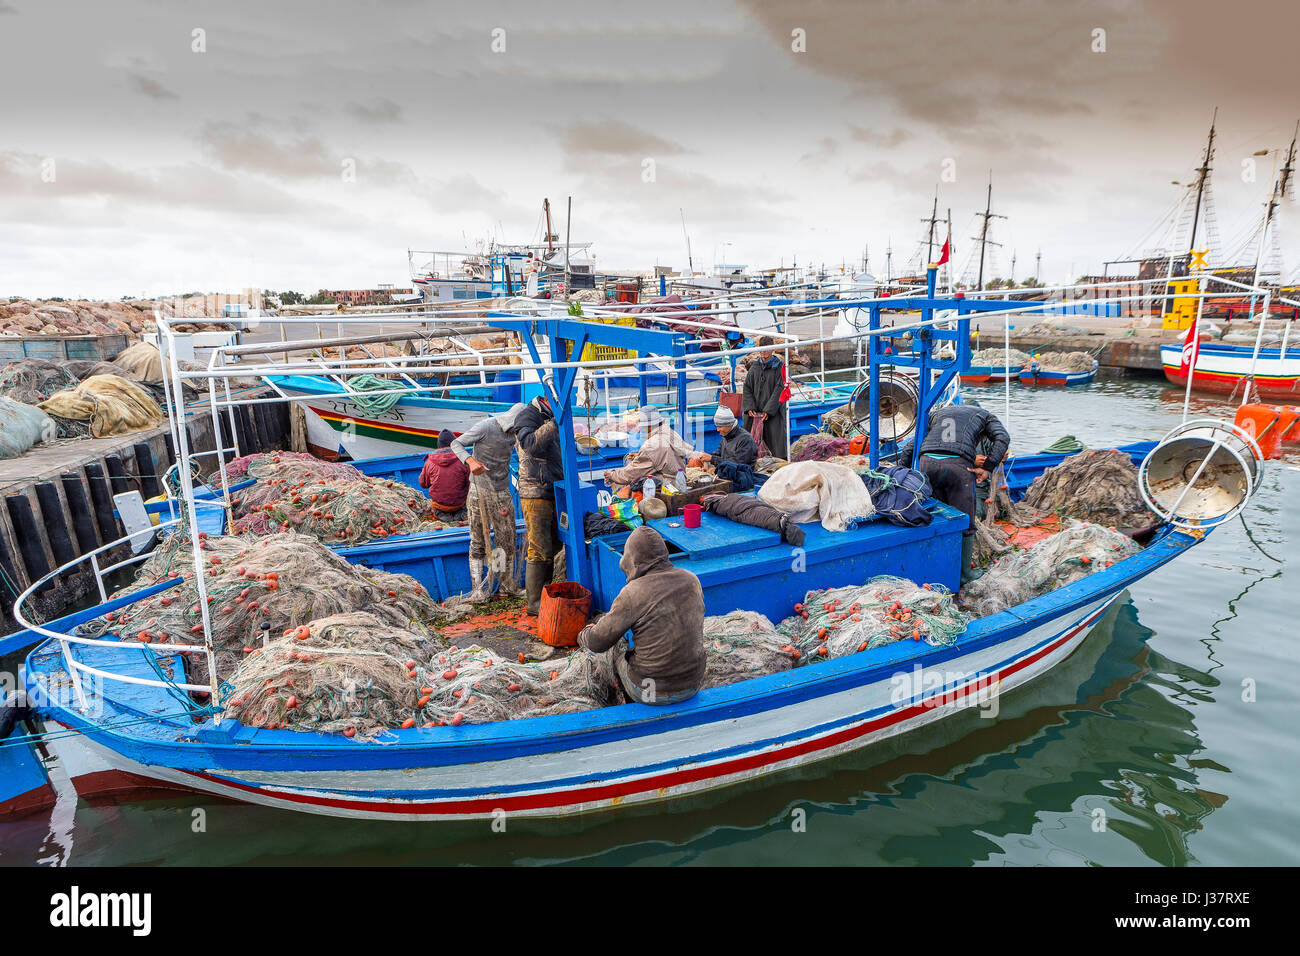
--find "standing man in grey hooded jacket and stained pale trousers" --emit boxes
[451,405,524,604]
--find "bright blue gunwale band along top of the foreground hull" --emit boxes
[29,515,1204,770]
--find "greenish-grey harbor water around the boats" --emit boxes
[0,380,1300,866]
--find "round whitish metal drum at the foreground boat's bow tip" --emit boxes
[1138,419,1264,528]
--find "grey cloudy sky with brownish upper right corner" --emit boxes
[0,0,1300,298]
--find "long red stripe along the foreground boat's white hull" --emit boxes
[178,598,1113,814]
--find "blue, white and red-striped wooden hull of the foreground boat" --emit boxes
[15,520,1200,821]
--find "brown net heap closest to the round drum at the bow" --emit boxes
[1023,449,1154,528]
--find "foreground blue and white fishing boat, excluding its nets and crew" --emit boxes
[0,272,1258,821]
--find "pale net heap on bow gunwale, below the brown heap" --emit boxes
[961,522,1141,618]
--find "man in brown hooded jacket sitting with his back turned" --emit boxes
[577,525,705,704]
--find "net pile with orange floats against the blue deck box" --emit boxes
[777,575,970,663]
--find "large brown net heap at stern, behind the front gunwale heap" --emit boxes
[83,532,445,683]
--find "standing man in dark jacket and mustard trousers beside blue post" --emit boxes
[515,395,564,615]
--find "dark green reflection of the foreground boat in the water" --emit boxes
[0,585,1227,865]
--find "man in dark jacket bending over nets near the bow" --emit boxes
[920,405,1011,584]
